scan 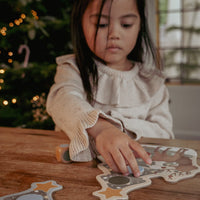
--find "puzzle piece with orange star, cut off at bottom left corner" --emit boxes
[0,181,63,200]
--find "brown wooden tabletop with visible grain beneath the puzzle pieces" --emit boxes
[0,127,200,200]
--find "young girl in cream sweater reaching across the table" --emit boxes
[47,0,174,177]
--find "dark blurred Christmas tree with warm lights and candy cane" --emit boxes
[0,0,72,129]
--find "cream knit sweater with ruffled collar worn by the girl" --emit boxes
[47,55,174,161]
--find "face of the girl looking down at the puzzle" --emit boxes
[82,0,140,66]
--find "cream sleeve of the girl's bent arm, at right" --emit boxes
[119,84,174,139]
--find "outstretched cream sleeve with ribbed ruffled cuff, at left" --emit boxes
[46,55,100,161]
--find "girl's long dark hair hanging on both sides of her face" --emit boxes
[71,0,160,103]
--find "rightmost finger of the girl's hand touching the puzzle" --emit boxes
[130,140,152,164]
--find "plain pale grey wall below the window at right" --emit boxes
[167,85,200,140]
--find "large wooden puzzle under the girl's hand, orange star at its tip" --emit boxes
[93,145,200,200]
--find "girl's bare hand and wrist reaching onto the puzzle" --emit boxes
[87,118,152,177]
